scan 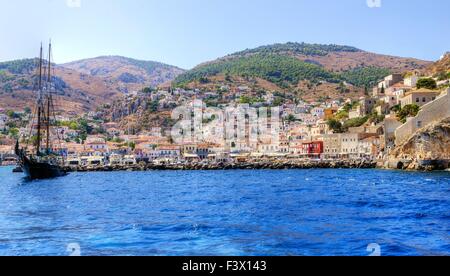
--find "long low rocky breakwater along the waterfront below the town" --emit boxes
[66,160,377,172]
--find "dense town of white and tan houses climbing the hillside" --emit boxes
[0,66,450,170]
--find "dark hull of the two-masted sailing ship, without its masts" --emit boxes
[20,153,67,180]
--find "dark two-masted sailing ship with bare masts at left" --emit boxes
[15,42,67,180]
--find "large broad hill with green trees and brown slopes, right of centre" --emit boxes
[174,43,431,99]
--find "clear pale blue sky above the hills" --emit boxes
[0,0,450,69]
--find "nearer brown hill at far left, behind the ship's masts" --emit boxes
[0,59,121,113]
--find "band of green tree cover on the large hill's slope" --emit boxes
[175,53,390,88]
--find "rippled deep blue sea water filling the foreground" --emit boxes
[0,167,450,256]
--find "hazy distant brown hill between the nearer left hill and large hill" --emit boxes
[61,56,184,93]
